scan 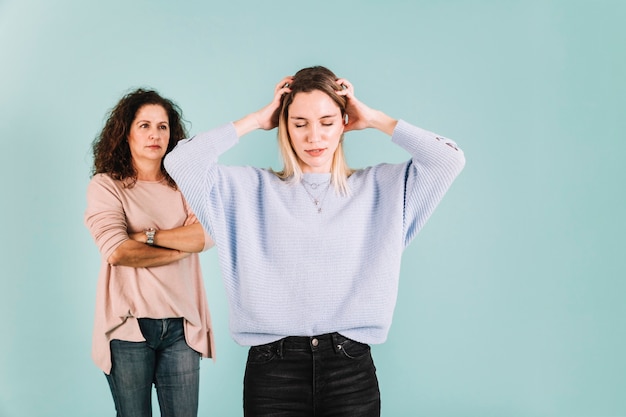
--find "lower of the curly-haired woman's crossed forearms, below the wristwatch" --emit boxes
[107,239,190,268]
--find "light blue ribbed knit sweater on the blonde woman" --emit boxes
[165,120,465,345]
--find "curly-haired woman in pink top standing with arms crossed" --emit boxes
[85,89,213,417]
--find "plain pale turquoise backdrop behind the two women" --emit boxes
[0,0,626,417]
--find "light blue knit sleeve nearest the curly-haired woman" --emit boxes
[164,123,239,236]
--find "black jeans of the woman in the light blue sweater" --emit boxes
[243,333,380,417]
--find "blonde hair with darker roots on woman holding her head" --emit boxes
[275,66,354,195]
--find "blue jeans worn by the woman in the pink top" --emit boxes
[106,318,200,417]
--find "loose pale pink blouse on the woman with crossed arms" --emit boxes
[85,174,215,374]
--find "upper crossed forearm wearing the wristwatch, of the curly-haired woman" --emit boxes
[130,223,213,253]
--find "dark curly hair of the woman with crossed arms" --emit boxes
[91,88,187,189]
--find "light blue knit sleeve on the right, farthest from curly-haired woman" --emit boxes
[392,120,465,247]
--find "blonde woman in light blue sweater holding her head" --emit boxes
[165,67,465,417]
